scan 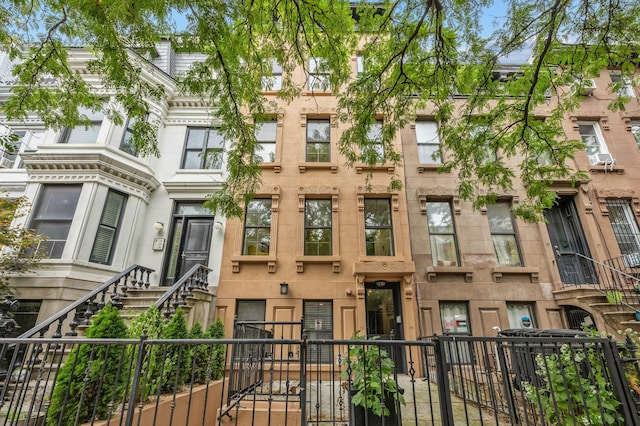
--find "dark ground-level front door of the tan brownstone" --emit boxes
[365,281,405,373]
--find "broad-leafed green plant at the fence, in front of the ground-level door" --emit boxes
[341,332,406,416]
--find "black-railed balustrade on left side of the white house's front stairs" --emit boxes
[18,265,154,339]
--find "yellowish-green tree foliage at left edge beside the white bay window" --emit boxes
[0,194,44,295]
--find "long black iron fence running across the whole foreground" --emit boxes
[0,332,640,426]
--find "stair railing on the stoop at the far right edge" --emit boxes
[564,252,640,311]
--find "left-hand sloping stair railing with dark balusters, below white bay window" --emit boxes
[18,265,154,338]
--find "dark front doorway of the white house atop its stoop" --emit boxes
[162,202,214,286]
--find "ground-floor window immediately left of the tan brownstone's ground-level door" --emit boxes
[303,300,333,364]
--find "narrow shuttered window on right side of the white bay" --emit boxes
[89,190,127,265]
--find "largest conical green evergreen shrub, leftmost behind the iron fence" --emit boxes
[47,304,128,426]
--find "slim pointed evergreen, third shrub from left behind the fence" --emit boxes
[160,307,193,392]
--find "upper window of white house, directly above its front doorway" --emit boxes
[182,127,224,170]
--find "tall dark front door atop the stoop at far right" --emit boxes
[545,196,598,284]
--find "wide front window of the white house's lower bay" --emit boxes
[31,185,82,259]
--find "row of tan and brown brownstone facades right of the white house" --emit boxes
[216,60,640,339]
